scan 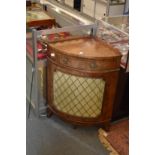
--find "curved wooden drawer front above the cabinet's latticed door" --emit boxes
[48,51,120,71]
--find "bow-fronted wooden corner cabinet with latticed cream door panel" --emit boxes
[47,36,121,130]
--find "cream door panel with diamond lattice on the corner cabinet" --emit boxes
[53,71,105,118]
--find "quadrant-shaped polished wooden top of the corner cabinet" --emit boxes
[49,37,121,58]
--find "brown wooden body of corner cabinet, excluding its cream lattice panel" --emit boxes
[47,37,121,130]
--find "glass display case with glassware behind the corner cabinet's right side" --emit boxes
[97,16,129,71]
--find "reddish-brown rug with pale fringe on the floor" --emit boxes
[98,120,129,155]
